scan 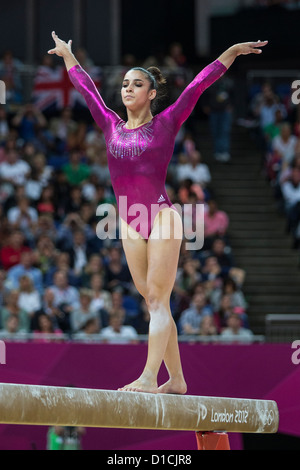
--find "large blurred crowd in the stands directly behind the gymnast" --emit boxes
[0,44,253,342]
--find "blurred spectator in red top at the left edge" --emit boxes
[0,230,31,271]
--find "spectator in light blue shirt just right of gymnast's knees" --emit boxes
[179,293,213,335]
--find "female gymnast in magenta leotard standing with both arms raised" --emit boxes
[48,31,267,394]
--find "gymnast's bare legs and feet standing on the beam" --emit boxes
[121,209,186,394]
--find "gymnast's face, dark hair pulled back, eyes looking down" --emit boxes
[121,70,156,111]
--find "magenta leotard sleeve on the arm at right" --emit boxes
[161,59,227,134]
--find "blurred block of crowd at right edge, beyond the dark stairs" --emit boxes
[250,82,300,249]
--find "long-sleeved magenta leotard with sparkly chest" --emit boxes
[69,60,227,240]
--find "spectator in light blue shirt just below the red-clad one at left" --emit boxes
[7,251,43,294]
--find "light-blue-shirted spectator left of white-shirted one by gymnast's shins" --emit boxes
[70,289,101,333]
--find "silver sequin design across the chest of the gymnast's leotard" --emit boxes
[108,121,153,158]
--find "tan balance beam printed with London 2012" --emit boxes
[0,383,279,433]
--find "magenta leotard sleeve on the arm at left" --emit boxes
[68,65,120,132]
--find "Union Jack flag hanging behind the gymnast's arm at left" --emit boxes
[32,65,101,111]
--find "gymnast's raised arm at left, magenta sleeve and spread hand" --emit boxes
[48,31,120,133]
